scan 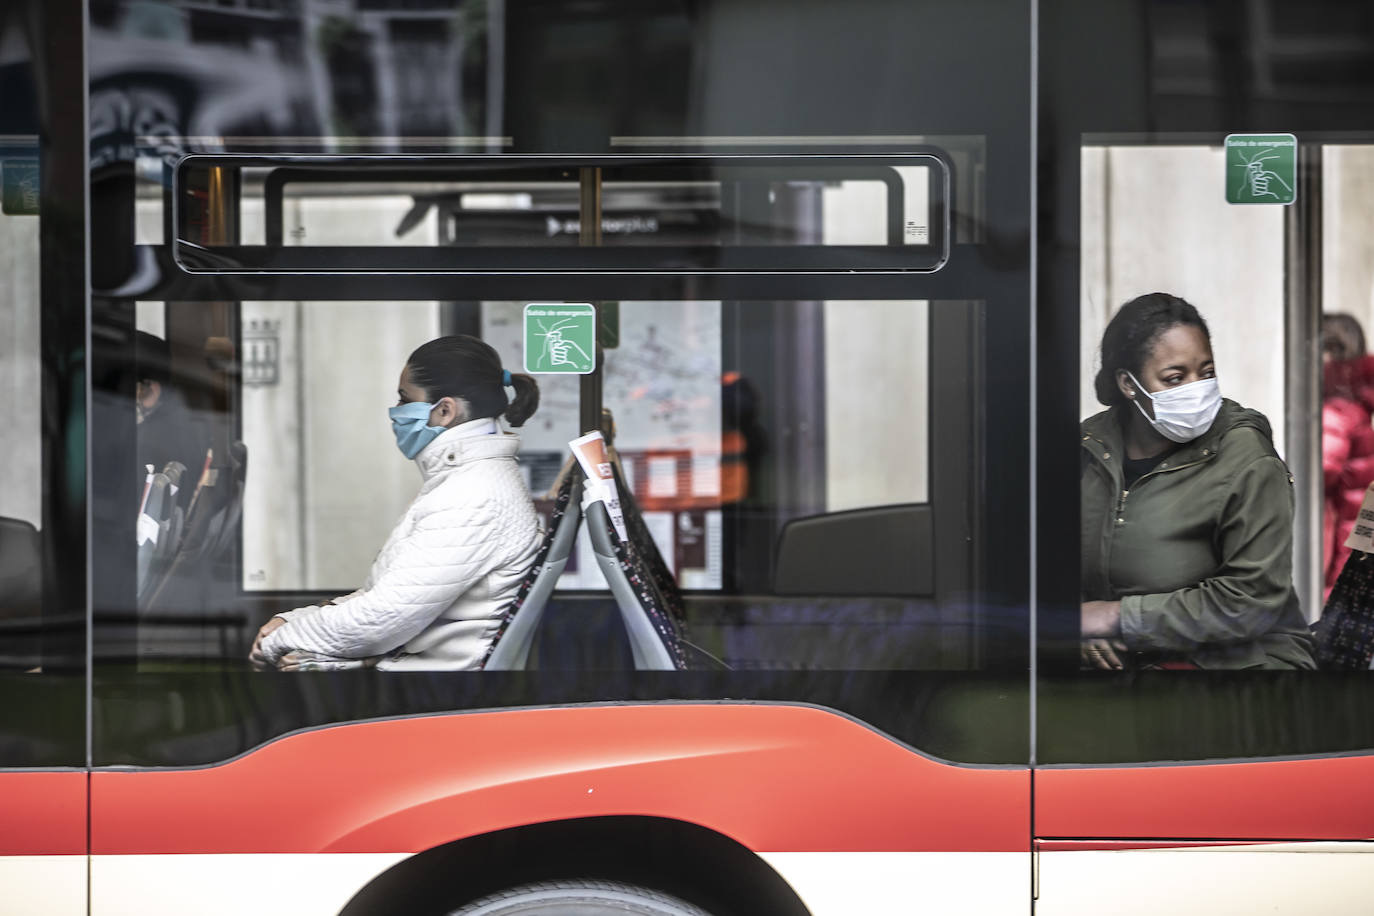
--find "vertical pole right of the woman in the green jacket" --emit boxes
[1283,141,1323,621]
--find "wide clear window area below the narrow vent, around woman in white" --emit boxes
[136,301,956,669]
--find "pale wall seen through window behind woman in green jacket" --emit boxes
[1079,147,1285,453]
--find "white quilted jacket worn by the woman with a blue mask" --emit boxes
[262,419,543,670]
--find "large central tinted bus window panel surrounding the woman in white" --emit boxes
[91,3,1032,765]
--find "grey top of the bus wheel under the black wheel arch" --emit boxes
[449,879,710,916]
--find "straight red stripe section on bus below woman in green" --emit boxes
[1035,757,1374,839]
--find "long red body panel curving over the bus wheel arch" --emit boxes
[92,705,1029,854]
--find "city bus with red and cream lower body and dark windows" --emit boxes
[0,0,1374,916]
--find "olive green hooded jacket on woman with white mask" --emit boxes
[1081,400,1316,667]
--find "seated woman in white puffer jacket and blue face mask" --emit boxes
[250,335,543,670]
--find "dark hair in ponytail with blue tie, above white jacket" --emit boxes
[405,334,539,426]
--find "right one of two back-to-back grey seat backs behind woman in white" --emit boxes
[584,500,687,672]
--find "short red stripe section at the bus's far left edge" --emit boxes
[0,770,87,862]
